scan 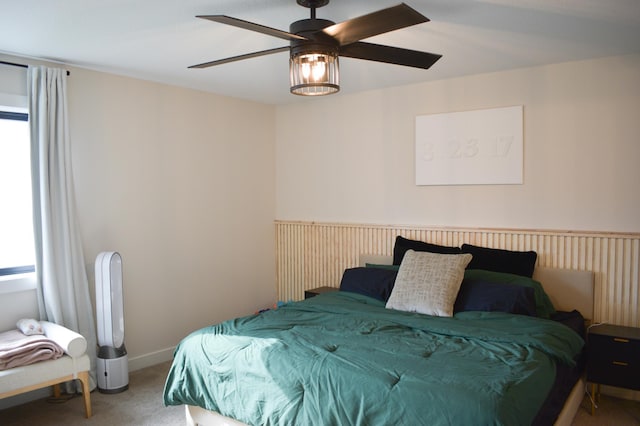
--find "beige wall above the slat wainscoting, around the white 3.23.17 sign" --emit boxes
[276,55,640,232]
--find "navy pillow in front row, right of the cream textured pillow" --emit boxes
[453,278,536,317]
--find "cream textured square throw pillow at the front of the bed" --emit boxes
[386,250,472,317]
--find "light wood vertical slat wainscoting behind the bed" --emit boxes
[275,221,640,327]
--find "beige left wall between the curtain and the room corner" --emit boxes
[0,55,276,368]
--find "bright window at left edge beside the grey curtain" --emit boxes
[0,107,35,278]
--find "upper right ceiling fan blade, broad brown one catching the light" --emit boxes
[322,3,429,46]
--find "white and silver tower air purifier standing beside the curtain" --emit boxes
[96,251,129,393]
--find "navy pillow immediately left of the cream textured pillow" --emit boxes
[340,268,398,303]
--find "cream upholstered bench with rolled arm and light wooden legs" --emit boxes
[0,321,91,418]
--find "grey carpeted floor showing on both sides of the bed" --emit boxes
[0,362,640,426]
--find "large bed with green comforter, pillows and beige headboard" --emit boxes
[164,239,593,425]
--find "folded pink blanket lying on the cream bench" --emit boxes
[0,330,64,370]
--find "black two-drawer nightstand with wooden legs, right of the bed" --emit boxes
[587,324,640,414]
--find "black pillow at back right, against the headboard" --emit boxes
[462,244,538,278]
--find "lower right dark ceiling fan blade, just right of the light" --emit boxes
[340,42,442,69]
